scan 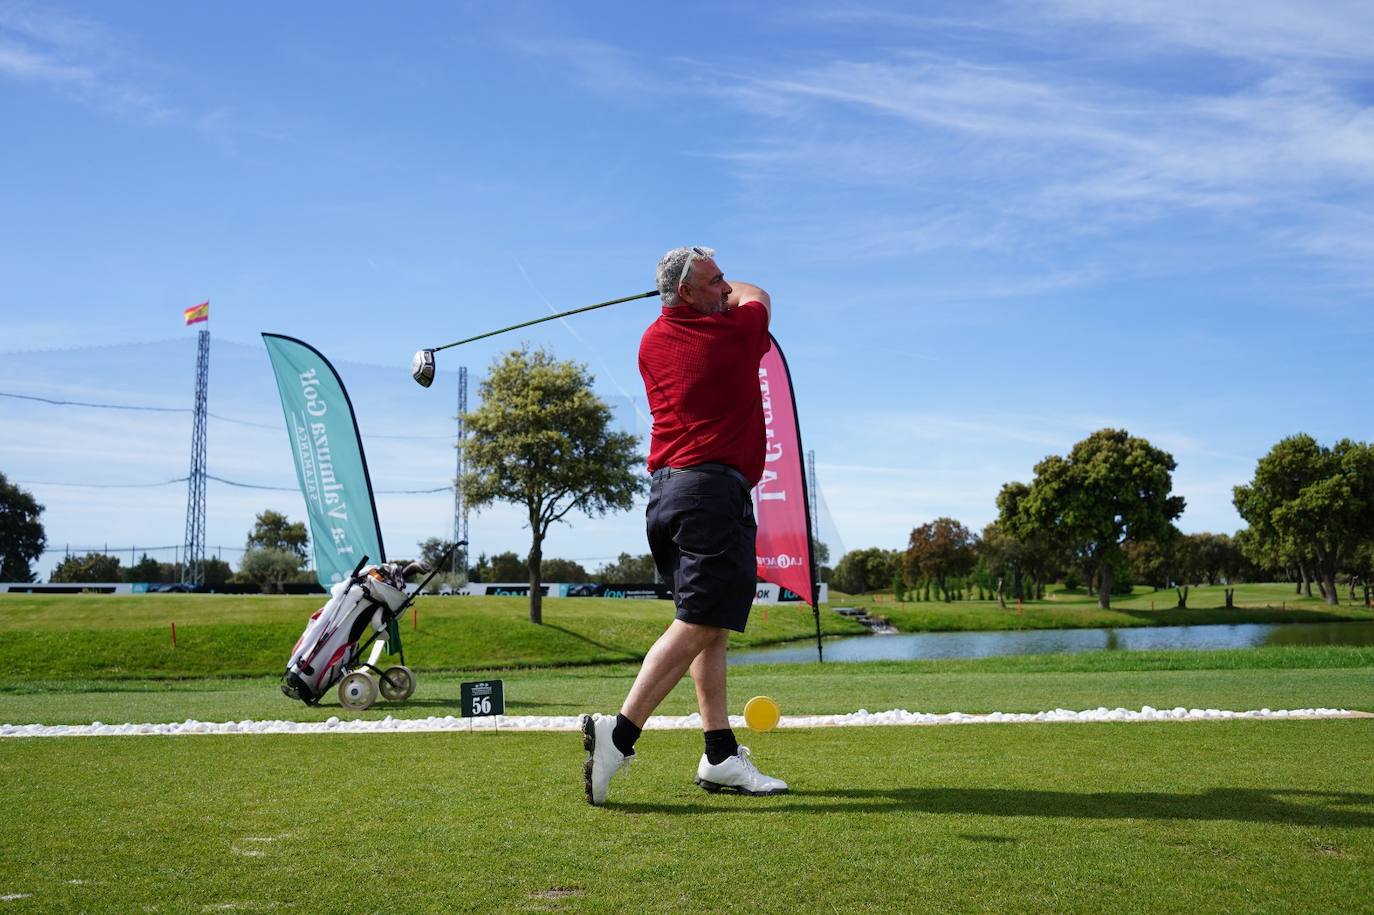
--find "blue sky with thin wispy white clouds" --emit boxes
[0,0,1374,577]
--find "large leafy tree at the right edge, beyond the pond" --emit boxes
[1234,434,1374,605]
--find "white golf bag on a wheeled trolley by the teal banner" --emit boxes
[282,559,415,710]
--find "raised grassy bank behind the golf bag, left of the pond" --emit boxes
[0,595,866,679]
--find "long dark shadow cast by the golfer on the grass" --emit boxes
[618,787,1374,828]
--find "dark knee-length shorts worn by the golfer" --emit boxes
[646,470,758,632]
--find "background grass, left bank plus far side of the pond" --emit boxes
[8,585,1374,680]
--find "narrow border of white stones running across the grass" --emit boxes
[0,706,1374,738]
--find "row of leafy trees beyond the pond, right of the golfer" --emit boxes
[834,429,1374,607]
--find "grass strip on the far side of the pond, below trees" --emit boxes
[831,584,1374,632]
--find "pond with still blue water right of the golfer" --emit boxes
[730,612,1374,664]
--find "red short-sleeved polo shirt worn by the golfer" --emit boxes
[639,302,771,485]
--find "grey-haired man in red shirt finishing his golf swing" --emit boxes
[581,247,787,805]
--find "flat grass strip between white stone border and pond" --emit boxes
[0,647,1374,724]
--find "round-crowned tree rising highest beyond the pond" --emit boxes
[1020,429,1184,609]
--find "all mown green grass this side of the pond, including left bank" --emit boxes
[0,595,1374,912]
